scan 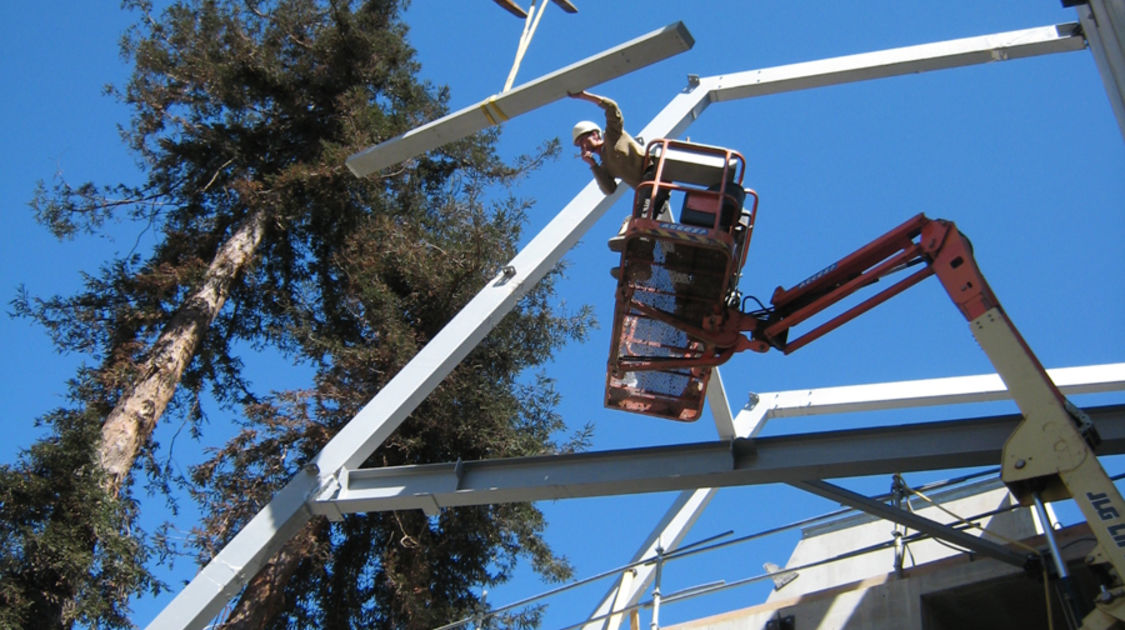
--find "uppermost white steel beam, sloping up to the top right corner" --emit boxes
[714,24,1086,101]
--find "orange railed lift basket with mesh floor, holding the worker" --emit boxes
[605,138,757,421]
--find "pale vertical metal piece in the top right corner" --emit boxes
[1077,0,1125,136]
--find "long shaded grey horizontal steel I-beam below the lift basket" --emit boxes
[311,405,1125,518]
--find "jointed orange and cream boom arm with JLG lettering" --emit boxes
[720,215,1125,630]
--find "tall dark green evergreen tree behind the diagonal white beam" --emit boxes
[0,0,587,628]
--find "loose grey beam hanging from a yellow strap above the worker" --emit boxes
[345,23,694,177]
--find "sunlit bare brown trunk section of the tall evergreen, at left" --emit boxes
[98,209,266,495]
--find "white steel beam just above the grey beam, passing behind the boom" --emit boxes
[735,363,1125,438]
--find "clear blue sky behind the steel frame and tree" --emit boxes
[0,0,1125,628]
